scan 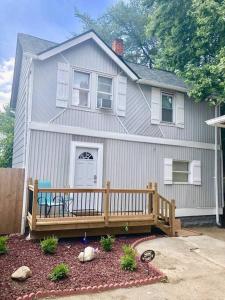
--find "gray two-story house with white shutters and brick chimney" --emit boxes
[11,31,222,232]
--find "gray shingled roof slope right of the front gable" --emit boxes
[126,62,187,88]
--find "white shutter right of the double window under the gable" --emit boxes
[116,75,127,117]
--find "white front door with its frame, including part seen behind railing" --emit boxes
[69,142,103,215]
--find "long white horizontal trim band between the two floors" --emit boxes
[30,122,220,150]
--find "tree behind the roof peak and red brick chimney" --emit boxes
[75,0,157,66]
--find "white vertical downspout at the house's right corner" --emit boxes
[214,106,221,227]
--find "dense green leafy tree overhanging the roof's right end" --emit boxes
[145,0,225,105]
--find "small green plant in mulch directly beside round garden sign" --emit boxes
[120,245,137,271]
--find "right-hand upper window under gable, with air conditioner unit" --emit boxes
[97,76,112,108]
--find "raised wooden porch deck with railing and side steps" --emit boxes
[27,180,178,236]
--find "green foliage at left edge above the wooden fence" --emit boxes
[0,105,14,168]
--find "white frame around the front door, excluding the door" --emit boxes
[69,142,103,188]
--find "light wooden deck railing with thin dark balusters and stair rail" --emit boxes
[28,180,175,235]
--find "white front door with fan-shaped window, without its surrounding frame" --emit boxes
[74,147,98,188]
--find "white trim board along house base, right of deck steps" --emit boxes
[176,207,223,217]
